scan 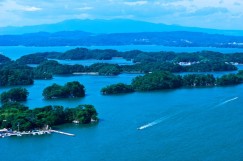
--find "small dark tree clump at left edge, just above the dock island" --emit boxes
[0,87,29,103]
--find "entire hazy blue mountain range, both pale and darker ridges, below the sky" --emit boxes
[0,19,243,48]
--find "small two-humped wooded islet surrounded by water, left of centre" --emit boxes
[42,81,85,99]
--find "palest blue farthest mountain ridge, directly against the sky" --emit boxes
[0,19,243,36]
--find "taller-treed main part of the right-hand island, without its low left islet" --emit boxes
[132,72,243,91]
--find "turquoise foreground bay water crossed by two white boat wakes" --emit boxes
[0,46,243,161]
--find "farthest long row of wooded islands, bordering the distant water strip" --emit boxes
[14,48,243,64]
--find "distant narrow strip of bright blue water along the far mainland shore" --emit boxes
[0,45,243,60]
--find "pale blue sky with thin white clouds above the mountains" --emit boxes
[0,0,243,30]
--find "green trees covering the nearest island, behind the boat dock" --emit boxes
[0,102,98,131]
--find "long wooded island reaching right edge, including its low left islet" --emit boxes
[101,71,243,95]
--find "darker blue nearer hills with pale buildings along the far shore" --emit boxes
[0,31,243,48]
